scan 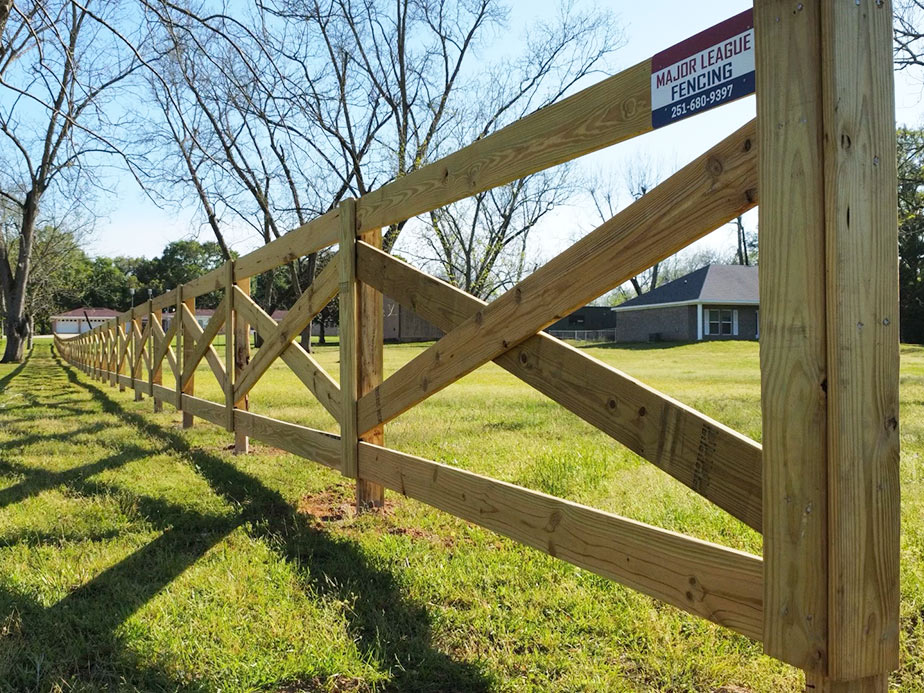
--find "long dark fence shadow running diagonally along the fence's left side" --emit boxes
[49,348,490,693]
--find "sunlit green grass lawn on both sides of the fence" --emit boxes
[0,342,924,693]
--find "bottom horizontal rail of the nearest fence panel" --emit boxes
[359,443,763,639]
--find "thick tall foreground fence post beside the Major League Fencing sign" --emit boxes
[754,0,899,693]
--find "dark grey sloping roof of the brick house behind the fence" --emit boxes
[616,265,760,310]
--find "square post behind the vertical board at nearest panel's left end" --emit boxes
[354,229,385,508]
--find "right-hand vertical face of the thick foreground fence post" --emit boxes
[822,0,900,680]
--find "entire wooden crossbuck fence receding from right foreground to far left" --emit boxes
[56,0,899,691]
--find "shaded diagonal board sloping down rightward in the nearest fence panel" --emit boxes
[357,243,761,531]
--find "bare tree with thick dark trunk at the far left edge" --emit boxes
[0,0,140,362]
